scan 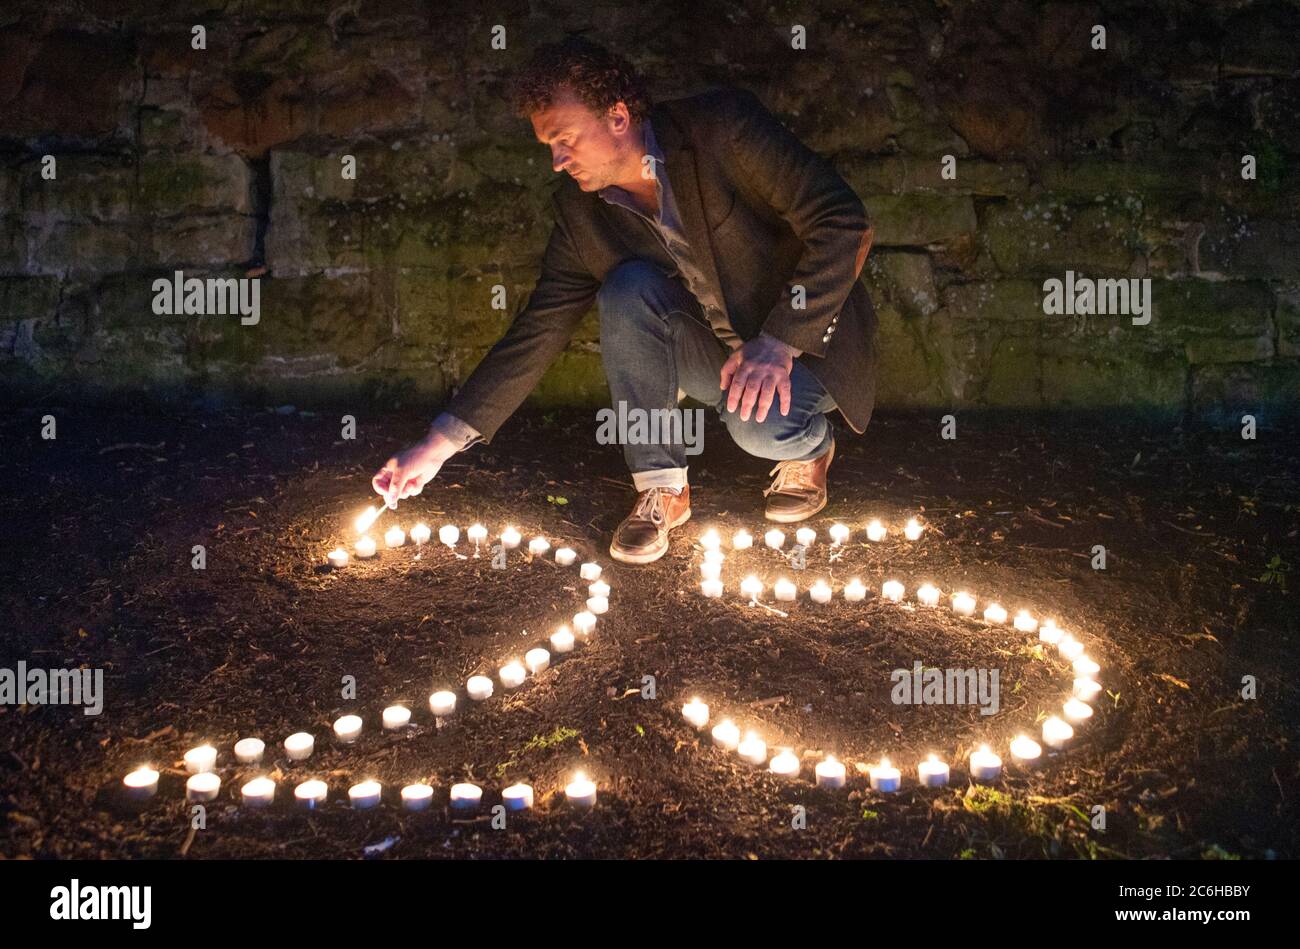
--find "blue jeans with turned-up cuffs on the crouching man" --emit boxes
[597,260,836,491]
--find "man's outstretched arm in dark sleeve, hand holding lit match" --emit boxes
[371,205,601,504]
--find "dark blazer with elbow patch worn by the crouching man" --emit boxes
[446,90,876,441]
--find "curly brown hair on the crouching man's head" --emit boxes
[511,36,651,122]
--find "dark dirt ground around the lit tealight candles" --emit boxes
[0,402,1300,859]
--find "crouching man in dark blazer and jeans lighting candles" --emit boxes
[373,39,876,563]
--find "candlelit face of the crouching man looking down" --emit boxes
[532,90,641,191]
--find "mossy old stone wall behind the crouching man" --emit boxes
[0,0,1300,410]
